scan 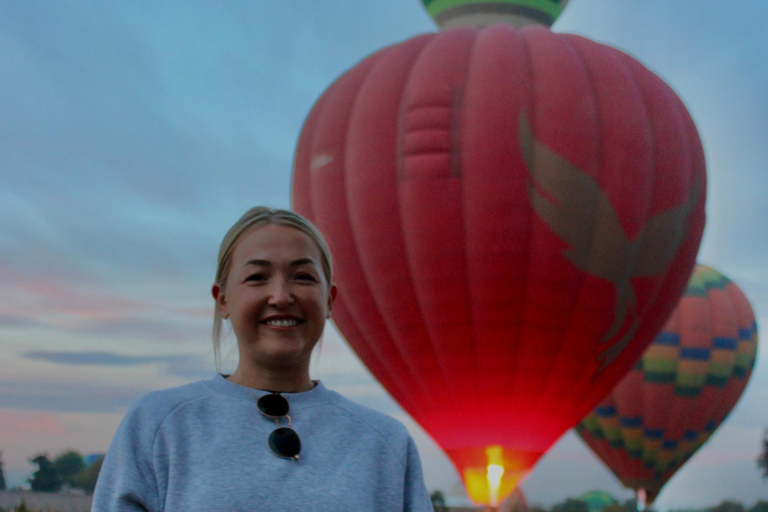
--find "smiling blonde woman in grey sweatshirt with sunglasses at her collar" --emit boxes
[92,207,432,512]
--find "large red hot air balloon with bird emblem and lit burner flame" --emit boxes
[293,25,705,504]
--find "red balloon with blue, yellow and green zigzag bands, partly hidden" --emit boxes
[576,265,757,504]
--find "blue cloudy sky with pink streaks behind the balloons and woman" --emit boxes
[0,0,768,510]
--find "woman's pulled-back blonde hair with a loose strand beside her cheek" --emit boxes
[213,206,333,372]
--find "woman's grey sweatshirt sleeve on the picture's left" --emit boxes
[91,402,160,512]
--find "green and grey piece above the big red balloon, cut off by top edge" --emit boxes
[421,0,569,30]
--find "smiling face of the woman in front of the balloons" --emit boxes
[213,224,336,368]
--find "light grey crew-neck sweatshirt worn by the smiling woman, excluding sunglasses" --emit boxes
[92,376,432,512]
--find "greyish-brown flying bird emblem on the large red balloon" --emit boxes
[519,114,701,372]
